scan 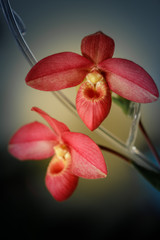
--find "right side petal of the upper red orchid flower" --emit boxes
[98,58,159,103]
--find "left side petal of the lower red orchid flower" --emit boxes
[8,122,57,160]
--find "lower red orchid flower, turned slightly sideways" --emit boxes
[9,107,107,201]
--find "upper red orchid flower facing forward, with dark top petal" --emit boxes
[26,32,159,130]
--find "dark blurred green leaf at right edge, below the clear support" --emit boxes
[133,162,160,191]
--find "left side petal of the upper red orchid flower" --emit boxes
[26,52,93,91]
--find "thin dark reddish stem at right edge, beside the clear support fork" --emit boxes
[139,119,160,164]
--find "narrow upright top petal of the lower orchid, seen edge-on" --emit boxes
[32,107,69,136]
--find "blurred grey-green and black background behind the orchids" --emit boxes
[0,0,160,239]
